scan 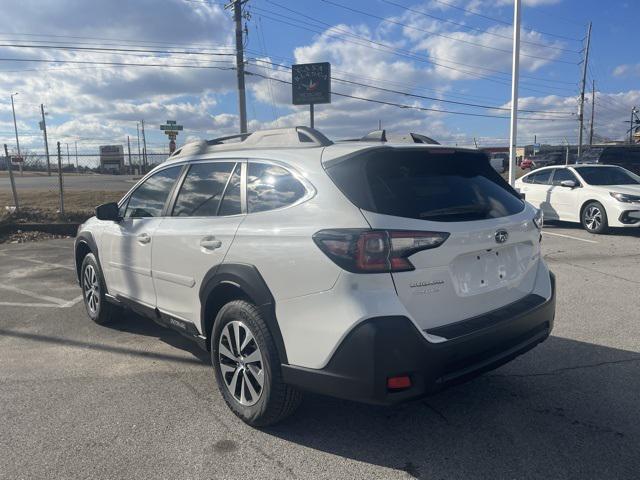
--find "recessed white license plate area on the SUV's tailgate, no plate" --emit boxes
[450,242,535,297]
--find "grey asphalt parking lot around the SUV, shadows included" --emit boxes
[0,225,640,479]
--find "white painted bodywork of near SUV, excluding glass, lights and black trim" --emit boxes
[76,137,551,369]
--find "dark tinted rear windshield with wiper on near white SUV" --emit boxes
[327,148,524,222]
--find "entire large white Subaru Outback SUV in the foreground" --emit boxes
[75,127,555,426]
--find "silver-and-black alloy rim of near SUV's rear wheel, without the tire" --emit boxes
[218,321,264,406]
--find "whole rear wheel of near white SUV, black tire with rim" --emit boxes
[211,300,301,427]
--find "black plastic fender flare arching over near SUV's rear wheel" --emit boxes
[199,263,287,363]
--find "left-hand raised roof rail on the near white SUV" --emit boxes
[171,126,333,157]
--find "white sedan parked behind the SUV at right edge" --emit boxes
[516,164,640,233]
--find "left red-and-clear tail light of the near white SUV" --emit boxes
[313,229,449,273]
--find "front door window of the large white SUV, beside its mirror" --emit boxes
[124,165,182,218]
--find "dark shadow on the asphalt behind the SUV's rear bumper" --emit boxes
[266,337,640,479]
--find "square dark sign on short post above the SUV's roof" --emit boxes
[291,62,331,128]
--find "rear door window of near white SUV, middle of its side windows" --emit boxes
[173,162,235,217]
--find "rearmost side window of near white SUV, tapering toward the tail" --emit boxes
[247,163,306,213]
